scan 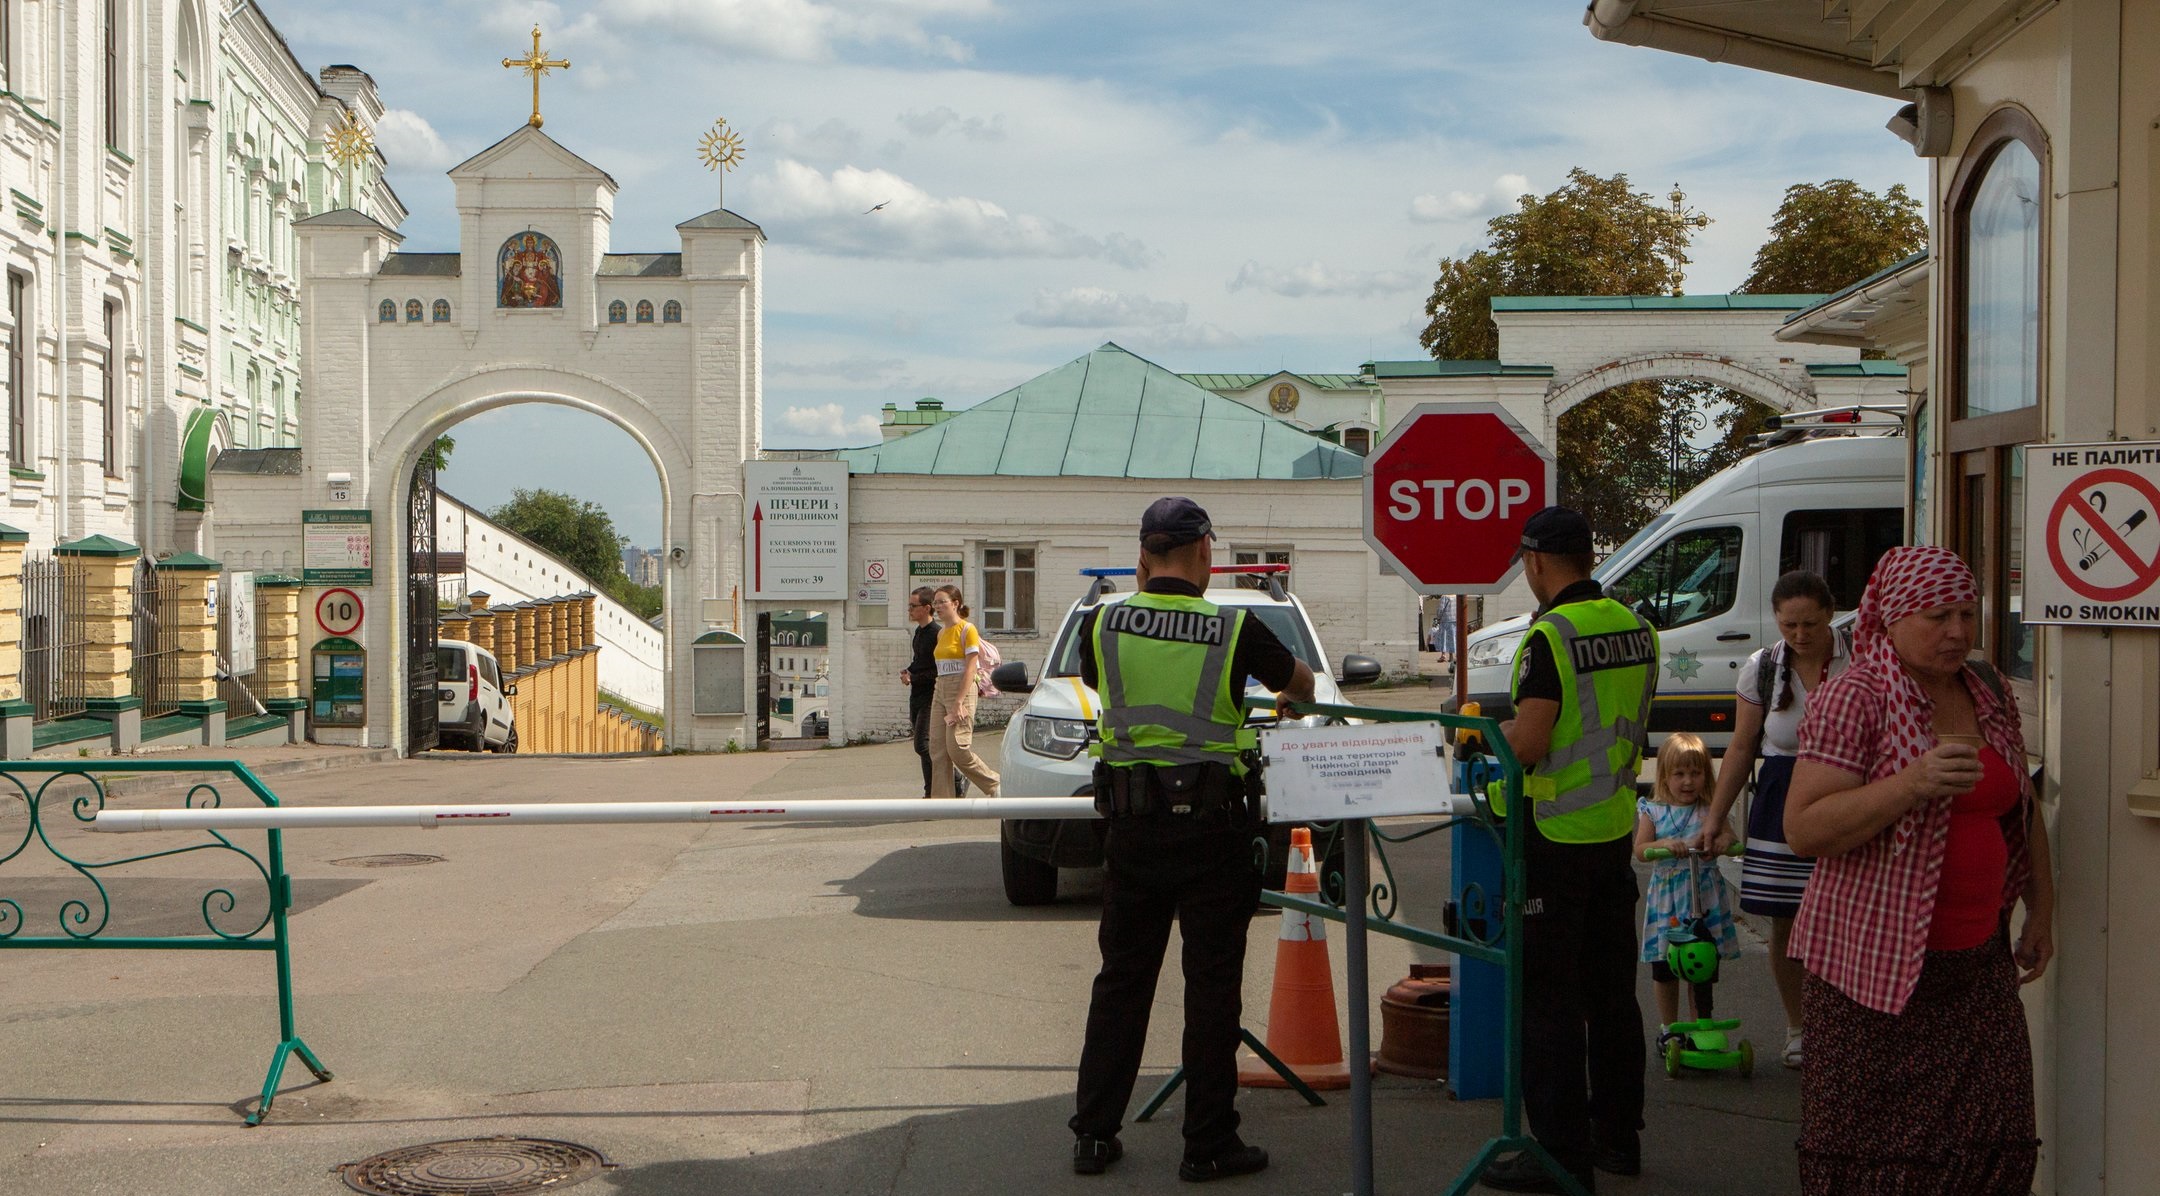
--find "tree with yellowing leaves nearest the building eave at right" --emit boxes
[1741,179,1927,296]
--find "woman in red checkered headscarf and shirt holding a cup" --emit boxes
[1784,548,2054,1196]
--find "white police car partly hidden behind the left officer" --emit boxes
[991,566,1380,905]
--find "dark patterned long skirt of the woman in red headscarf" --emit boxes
[1799,930,2039,1196]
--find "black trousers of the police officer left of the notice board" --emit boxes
[1067,810,1259,1159]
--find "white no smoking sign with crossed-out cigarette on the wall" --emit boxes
[2022,443,2160,626]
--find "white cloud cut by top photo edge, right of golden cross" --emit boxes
[607,0,991,63]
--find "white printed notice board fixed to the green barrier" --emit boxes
[1259,723,1454,823]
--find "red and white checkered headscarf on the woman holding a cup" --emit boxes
[1853,546,2024,773]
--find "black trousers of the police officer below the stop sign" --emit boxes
[1523,827,1646,1172]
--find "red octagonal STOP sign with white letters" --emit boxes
[1365,404,1560,594]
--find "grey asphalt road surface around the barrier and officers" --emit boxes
[0,729,1797,1196]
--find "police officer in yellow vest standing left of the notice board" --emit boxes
[1067,490,1313,1181]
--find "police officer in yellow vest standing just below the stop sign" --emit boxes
[1482,507,1657,1192]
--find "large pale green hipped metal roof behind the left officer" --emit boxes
[840,343,1365,479]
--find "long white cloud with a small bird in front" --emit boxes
[750,160,1153,268]
